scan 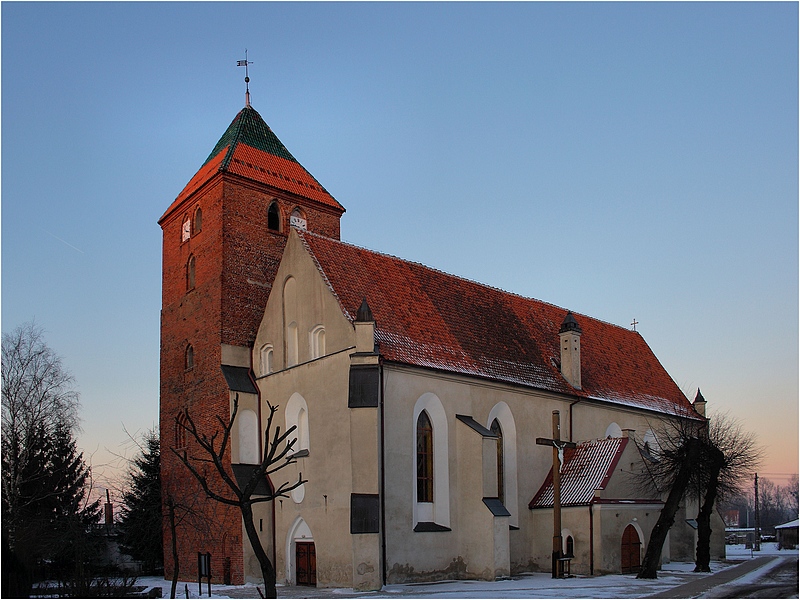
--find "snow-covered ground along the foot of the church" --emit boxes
[137,543,798,600]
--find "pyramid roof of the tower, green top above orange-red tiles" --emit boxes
[162,106,344,219]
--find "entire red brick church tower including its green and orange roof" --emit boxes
[158,102,344,583]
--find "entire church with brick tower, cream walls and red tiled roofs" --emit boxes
[159,102,724,590]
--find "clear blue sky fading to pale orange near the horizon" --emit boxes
[2,2,798,492]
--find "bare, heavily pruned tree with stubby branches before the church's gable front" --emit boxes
[172,394,306,598]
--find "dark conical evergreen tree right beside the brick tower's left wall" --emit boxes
[119,430,164,572]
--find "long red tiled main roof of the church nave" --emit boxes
[297,231,694,414]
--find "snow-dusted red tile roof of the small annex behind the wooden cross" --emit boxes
[528,438,628,508]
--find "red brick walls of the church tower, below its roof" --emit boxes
[160,173,341,583]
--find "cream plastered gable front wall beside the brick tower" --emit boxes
[254,235,364,587]
